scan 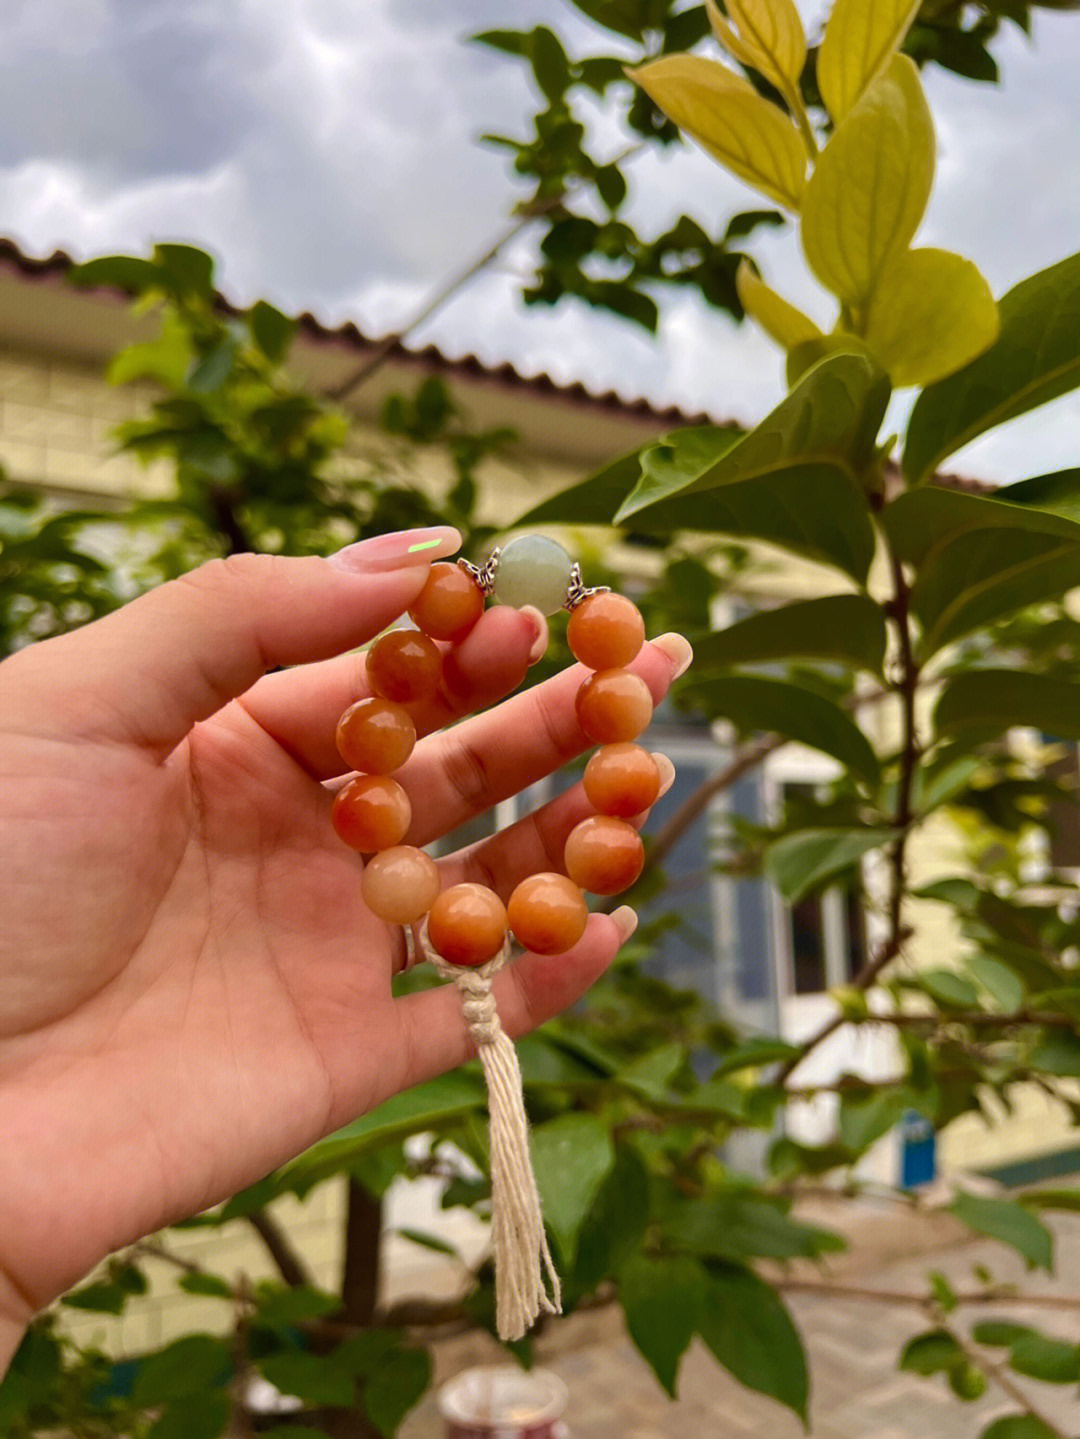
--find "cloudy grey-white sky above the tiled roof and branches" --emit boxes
[0,0,1080,479]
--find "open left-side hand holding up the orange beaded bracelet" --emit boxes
[0,530,689,1371]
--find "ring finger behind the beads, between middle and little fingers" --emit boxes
[439,753,674,901]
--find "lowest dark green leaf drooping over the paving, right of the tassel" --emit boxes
[699,1265,810,1423]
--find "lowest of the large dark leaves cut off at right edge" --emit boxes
[933,669,1080,740]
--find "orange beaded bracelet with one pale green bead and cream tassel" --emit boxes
[332,535,673,1340]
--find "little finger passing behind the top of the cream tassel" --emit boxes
[380,905,637,1101]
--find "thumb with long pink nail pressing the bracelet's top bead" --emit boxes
[9,525,462,757]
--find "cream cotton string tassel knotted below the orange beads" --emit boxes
[418,921,562,1340]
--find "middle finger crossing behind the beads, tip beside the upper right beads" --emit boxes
[395,635,690,845]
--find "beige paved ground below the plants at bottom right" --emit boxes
[400,1203,1080,1439]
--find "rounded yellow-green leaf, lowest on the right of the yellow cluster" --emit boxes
[863,249,999,387]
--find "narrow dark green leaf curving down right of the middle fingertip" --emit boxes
[686,675,880,789]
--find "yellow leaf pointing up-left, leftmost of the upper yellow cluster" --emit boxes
[628,55,807,210]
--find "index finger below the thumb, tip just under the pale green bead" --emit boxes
[243,604,548,780]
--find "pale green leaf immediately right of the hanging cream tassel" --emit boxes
[532,1114,615,1265]
